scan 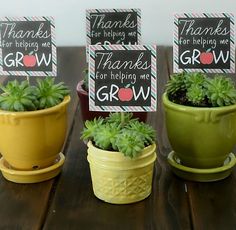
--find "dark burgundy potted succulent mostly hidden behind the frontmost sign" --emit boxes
[76,69,147,122]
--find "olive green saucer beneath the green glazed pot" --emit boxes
[167,151,236,182]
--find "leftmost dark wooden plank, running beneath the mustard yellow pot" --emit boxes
[0,48,85,230]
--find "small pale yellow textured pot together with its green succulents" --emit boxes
[82,113,156,204]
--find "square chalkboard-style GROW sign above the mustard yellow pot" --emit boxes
[0,17,57,76]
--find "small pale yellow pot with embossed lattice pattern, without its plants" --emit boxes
[88,142,156,204]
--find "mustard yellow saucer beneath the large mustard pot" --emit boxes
[0,153,65,184]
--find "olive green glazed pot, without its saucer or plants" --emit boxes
[162,93,236,168]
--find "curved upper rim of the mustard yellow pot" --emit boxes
[0,95,71,117]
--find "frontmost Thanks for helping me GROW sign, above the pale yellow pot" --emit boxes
[89,45,157,112]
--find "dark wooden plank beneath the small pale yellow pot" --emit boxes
[44,47,191,230]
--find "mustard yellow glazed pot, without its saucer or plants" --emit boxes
[0,96,70,170]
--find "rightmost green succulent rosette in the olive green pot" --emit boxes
[206,75,236,106]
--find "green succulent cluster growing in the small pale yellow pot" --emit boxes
[81,113,155,158]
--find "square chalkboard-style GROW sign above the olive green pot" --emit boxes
[173,13,235,73]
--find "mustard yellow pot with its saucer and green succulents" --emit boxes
[0,77,70,183]
